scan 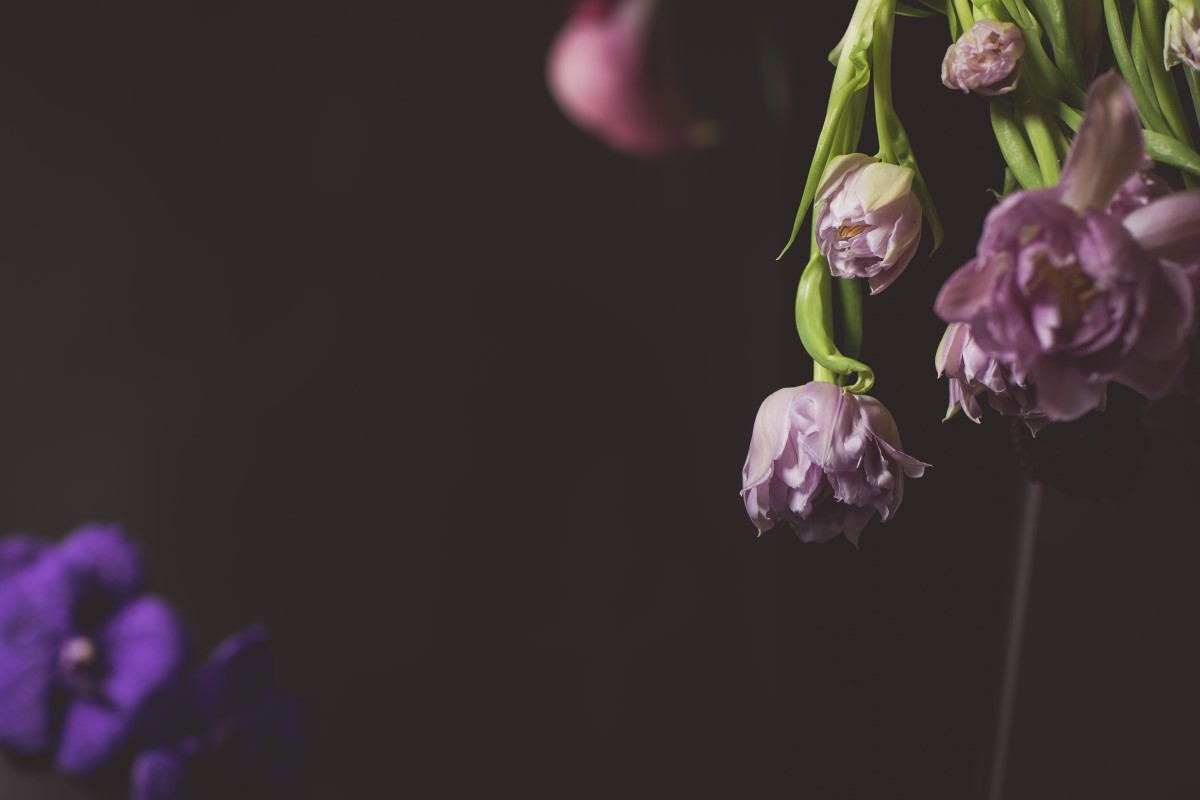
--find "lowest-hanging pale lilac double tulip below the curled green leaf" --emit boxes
[742,381,929,543]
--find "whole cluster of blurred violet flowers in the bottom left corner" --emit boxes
[0,525,304,800]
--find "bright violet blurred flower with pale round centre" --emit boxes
[0,527,187,775]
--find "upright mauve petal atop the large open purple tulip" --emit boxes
[1058,72,1146,211]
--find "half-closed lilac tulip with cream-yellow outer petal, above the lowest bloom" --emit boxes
[816,152,920,294]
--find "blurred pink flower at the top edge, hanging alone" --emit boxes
[546,0,714,156]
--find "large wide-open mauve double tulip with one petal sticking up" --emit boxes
[935,73,1200,421]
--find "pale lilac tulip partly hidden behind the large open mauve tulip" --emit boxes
[935,323,1046,432]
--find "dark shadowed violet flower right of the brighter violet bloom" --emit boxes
[131,626,304,800]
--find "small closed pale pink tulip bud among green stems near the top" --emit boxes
[942,19,1025,95]
